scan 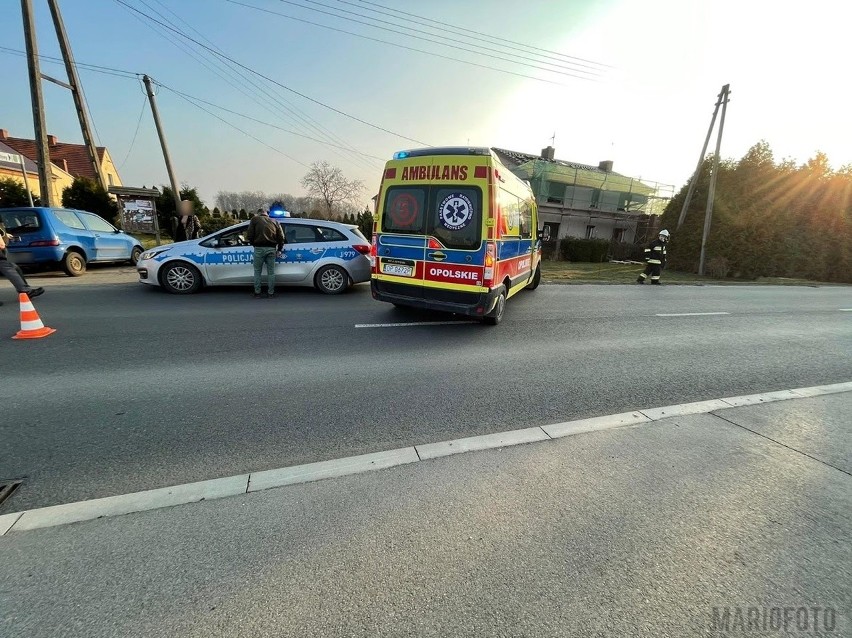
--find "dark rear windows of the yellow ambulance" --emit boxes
[382,185,482,250]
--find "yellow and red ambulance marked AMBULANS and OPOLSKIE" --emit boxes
[371,147,541,325]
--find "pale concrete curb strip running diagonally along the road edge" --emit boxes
[0,381,852,536]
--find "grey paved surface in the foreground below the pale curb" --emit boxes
[0,393,852,638]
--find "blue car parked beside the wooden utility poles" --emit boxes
[0,208,142,277]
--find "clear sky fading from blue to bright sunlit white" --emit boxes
[0,0,852,207]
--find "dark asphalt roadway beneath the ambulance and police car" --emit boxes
[0,278,852,512]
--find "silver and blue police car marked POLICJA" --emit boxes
[136,216,370,295]
